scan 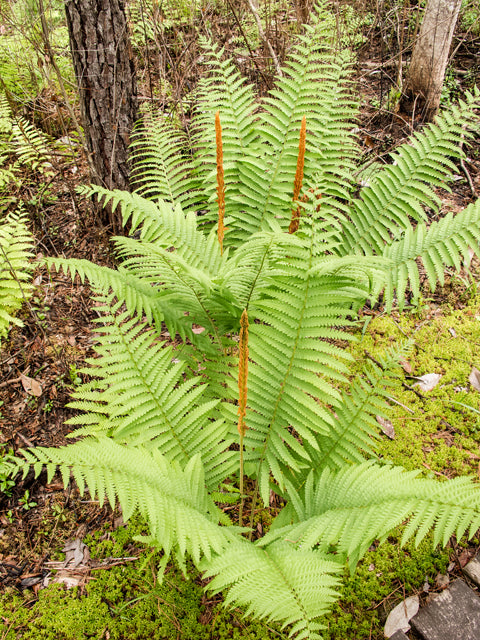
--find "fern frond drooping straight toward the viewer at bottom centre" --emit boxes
[201,541,342,640]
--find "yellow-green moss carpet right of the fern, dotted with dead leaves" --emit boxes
[352,297,480,477]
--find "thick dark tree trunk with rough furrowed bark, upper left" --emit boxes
[65,0,137,226]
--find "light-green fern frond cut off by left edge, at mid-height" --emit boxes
[0,213,33,339]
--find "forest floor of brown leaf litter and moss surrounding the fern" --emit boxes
[0,11,480,640]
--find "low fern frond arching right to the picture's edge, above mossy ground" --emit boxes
[261,462,480,570]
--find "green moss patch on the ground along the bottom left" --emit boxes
[0,517,286,640]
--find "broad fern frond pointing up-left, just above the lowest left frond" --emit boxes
[69,303,236,488]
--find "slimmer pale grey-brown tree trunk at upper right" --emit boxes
[402,0,462,120]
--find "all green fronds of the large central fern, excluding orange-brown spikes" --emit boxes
[5,6,480,638]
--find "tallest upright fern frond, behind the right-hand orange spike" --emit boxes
[230,8,357,239]
